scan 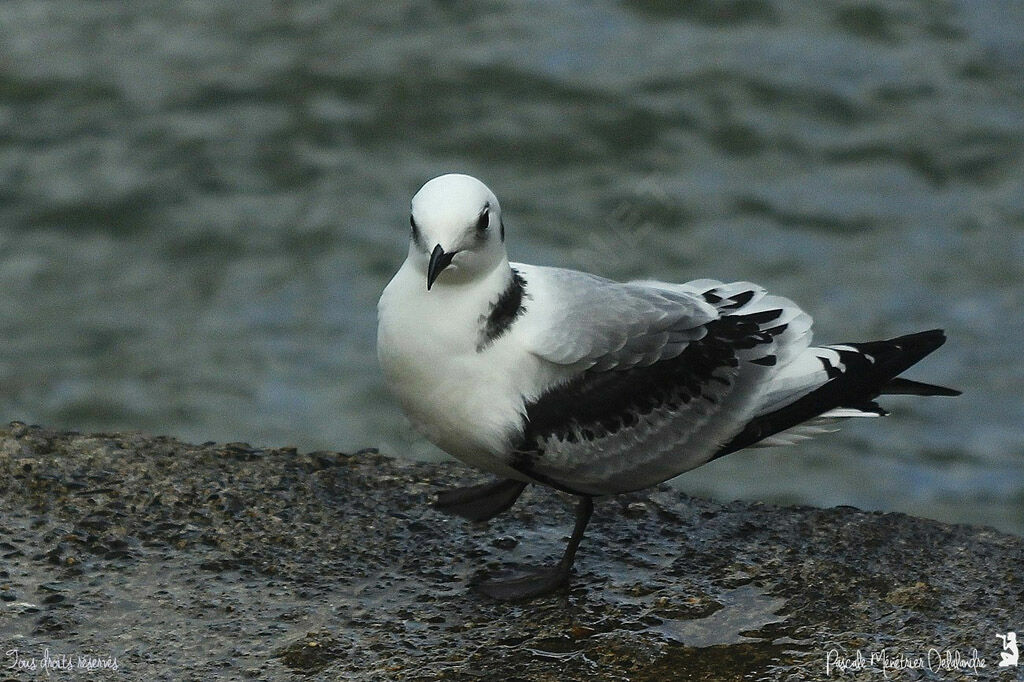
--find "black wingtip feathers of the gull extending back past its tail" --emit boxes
[713,330,959,459]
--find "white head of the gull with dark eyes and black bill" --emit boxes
[409,173,507,289]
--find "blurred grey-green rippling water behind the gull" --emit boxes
[0,0,1024,534]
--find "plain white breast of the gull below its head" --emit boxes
[377,262,539,478]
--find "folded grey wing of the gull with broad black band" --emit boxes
[513,264,810,495]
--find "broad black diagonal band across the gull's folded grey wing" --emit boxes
[513,309,785,476]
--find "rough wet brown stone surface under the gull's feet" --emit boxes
[0,423,1024,680]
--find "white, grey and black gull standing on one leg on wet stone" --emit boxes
[377,173,959,601]
